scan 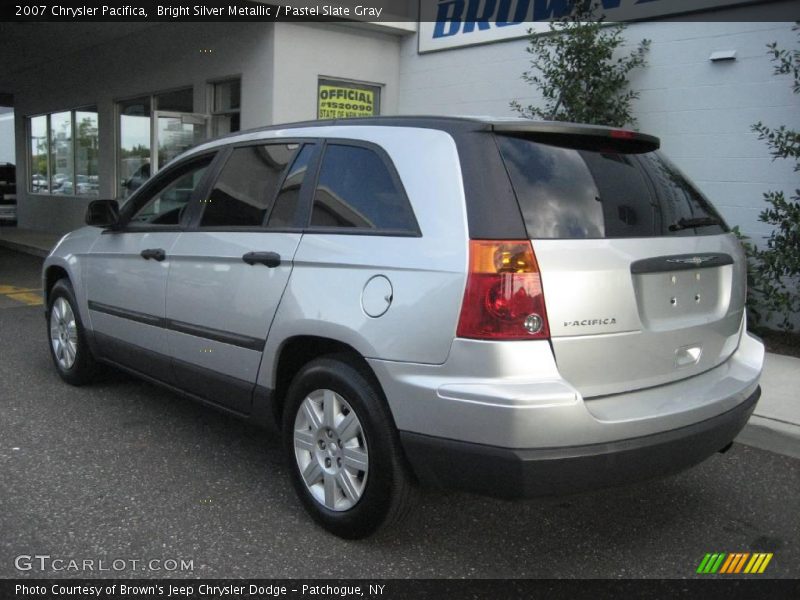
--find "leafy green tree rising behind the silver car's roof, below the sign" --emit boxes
[511,0,650,127]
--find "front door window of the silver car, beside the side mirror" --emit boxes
[129,156,213,227]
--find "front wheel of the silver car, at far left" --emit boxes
[47,279,97,385]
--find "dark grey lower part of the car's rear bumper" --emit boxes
[400,387,761,499]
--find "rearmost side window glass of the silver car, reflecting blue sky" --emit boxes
[311,144,417,231]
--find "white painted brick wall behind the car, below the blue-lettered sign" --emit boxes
[399,22,800,237]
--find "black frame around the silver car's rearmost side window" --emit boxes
[303,138,422,237]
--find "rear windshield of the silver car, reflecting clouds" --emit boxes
[495,135,728,239]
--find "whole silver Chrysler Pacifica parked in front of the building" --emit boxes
[43,117,764,538]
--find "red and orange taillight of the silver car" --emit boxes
[457,240,550,340]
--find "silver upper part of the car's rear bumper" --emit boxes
[370,334,764,450]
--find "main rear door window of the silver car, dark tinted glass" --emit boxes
[200,144,294,227]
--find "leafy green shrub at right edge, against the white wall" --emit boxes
[748,23,800,331]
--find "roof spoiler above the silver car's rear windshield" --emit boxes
[491,121,661,154]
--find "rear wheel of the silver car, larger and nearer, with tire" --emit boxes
[283,357,413,539]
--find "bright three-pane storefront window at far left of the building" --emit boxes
[28,107,100,196]
